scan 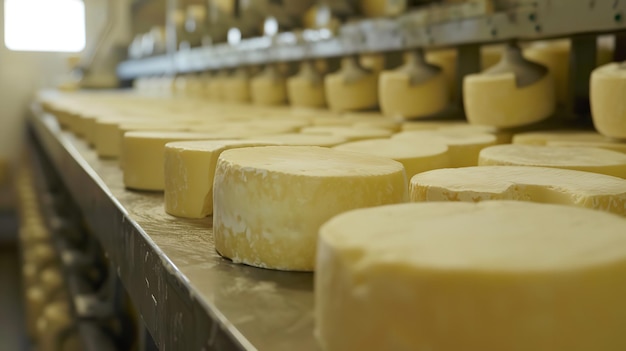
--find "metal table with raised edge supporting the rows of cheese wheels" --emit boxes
[29,108,318,351]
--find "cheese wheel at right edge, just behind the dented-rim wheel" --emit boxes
[478,144,626,178]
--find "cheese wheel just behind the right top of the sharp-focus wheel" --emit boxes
[334,139,450,179]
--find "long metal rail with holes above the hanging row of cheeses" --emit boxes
[117,0,626,80]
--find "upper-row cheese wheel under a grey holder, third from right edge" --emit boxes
[378,70,449,119]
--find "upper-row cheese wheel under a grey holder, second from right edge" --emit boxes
[463,73,556,128]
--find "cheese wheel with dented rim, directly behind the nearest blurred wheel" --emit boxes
[410,166,626,216]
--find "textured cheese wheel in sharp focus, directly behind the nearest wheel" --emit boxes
[213,146,408,271]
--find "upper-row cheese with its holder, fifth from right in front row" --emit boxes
[287,61,326,108]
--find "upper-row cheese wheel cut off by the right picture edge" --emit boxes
[590,63,626,139]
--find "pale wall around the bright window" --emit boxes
[0,0,110,159]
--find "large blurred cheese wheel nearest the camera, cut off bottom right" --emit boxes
[315,201,626,351]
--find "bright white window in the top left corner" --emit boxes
[4,0,85,52]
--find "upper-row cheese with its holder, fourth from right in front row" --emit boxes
[324,57,378,112]
